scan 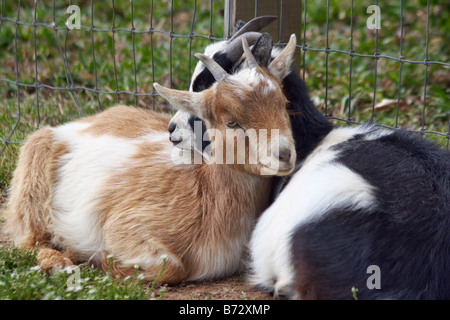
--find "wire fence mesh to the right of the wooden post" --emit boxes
[300,1,450,145]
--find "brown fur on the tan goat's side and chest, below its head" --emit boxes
[98,136,271,283]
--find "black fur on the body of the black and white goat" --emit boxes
[292,130,450,299]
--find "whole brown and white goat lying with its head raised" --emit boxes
[5,35,295,283]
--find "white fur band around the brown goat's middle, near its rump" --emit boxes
[51,123,137,259]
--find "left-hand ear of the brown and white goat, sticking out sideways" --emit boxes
[153,83,203,117]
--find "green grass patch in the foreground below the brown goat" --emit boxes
[0,246,154,300]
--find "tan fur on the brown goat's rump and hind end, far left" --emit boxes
[3,128,79,271]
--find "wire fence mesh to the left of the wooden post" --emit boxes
[0,0,222,156]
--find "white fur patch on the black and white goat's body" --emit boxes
[250,127,375,292]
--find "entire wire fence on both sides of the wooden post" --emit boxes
[0,0,450,175]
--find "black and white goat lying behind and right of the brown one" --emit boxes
[167,16,450,299]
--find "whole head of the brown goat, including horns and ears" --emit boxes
[155,35,296,175]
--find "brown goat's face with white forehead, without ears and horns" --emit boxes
[203,67,295,175]
